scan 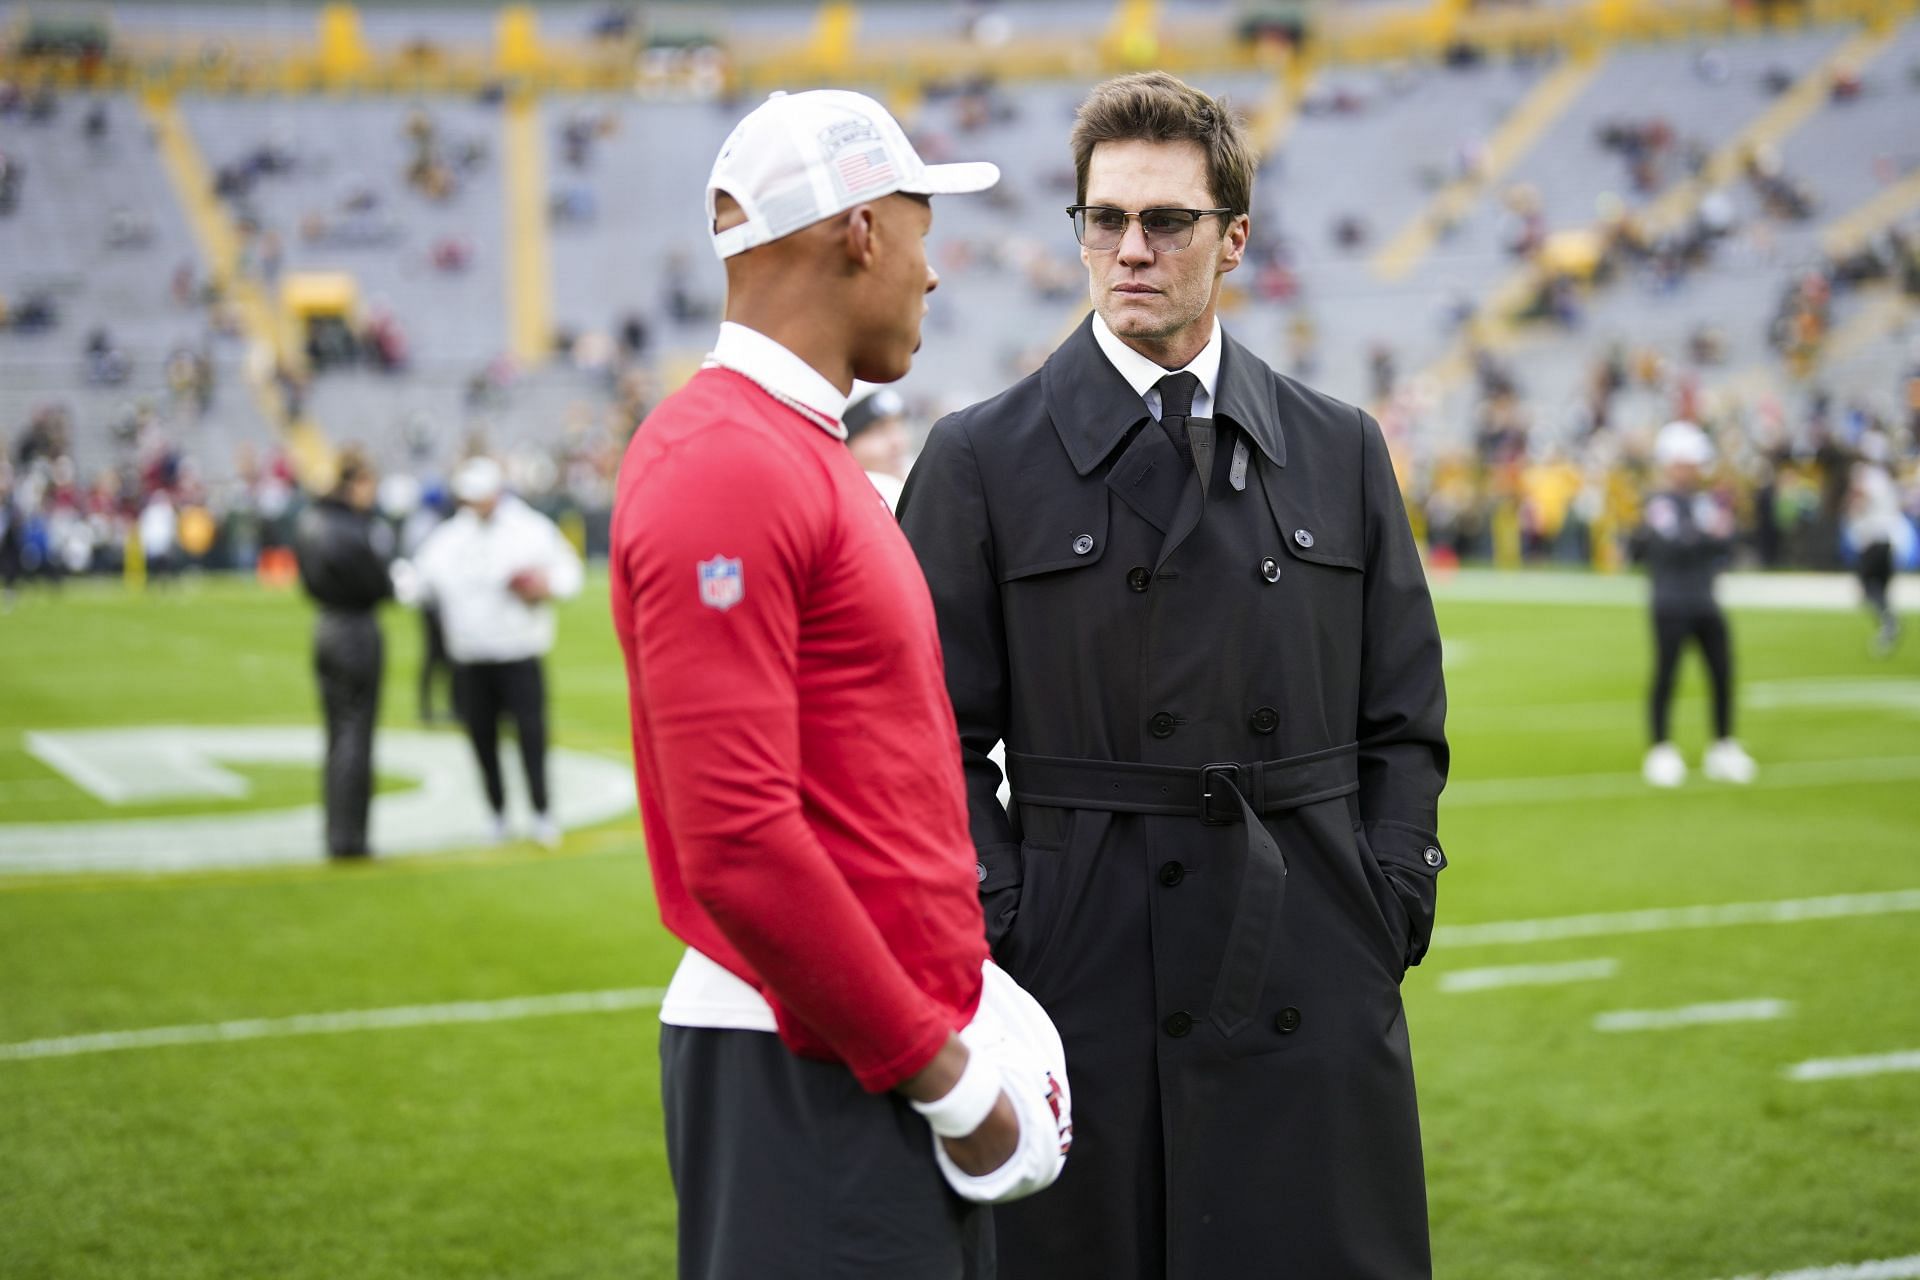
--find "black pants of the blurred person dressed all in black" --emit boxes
[313,612,384,858]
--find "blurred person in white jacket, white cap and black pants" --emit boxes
[396,457,586,848]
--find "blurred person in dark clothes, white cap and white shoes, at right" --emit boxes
[1634,422,1755,787]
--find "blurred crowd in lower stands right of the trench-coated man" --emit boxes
[1379,342,1920,570]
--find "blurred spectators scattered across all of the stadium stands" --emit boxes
[0,32,1920,606]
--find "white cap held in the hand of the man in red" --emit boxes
[933,960,1073,1205]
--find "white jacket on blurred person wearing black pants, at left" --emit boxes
[408,493,586,662]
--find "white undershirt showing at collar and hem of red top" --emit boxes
[660,320,847,1031]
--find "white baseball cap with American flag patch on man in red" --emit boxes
[707,88,1000,259]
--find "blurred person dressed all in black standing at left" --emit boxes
[294,449,392,858]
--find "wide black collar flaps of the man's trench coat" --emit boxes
[1041,311,1286,476]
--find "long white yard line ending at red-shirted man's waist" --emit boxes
[0,986,664,1061]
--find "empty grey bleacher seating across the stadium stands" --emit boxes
[0,4,1920,510]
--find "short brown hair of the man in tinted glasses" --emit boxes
[1073,71,1258,213]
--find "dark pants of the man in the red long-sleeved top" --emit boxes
[660,1027,995,1280]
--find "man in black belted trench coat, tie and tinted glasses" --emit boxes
[900,73,1448,1280]
